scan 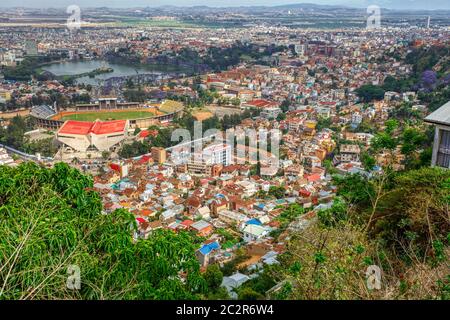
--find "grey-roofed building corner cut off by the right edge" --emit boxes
[425,101,450,169]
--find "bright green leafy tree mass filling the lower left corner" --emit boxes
[0,163,207,299]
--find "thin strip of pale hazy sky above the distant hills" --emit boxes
[0,0,450,10]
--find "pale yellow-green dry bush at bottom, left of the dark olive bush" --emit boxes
[279,223,379,300]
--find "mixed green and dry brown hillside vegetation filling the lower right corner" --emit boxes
[256,167,450,300]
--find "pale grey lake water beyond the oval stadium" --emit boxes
[42,60,161,85]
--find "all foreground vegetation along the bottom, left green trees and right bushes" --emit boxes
[0,163,450,300]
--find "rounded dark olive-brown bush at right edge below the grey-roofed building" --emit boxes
[371,167,450,257]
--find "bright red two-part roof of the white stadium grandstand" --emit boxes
[59,120,127,135]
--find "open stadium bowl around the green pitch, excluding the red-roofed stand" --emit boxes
[30,97,184,131]
